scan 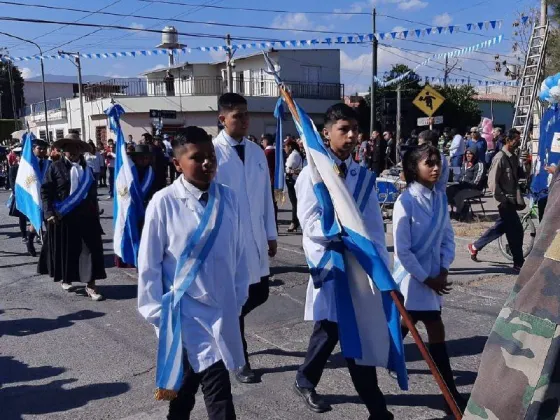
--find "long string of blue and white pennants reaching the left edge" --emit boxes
[1,18,508,62]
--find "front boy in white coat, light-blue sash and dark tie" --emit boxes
[138,127,248,420]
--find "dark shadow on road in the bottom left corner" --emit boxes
[0,379,130,420]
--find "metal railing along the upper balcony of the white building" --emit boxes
[84,77,344,101]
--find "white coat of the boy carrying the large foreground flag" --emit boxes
[296,157,389,322]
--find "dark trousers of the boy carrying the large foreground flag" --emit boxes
[296,320,393,420]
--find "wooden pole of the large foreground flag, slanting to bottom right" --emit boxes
[279,85,463,420]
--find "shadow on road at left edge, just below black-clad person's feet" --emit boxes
[0,310,105,337]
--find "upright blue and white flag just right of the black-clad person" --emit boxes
[105,104,144,266]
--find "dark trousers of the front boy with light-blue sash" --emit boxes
[167,355,236,420]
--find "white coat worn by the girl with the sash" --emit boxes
[393,182,455,311]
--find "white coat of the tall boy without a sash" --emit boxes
[214,130,278,284]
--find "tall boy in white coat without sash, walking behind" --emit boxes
[214,93,277,383]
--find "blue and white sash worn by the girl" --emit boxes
[393,192,447,284]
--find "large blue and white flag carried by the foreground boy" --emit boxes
[264,53,408,390]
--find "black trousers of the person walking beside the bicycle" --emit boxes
[474,204,525,267]
